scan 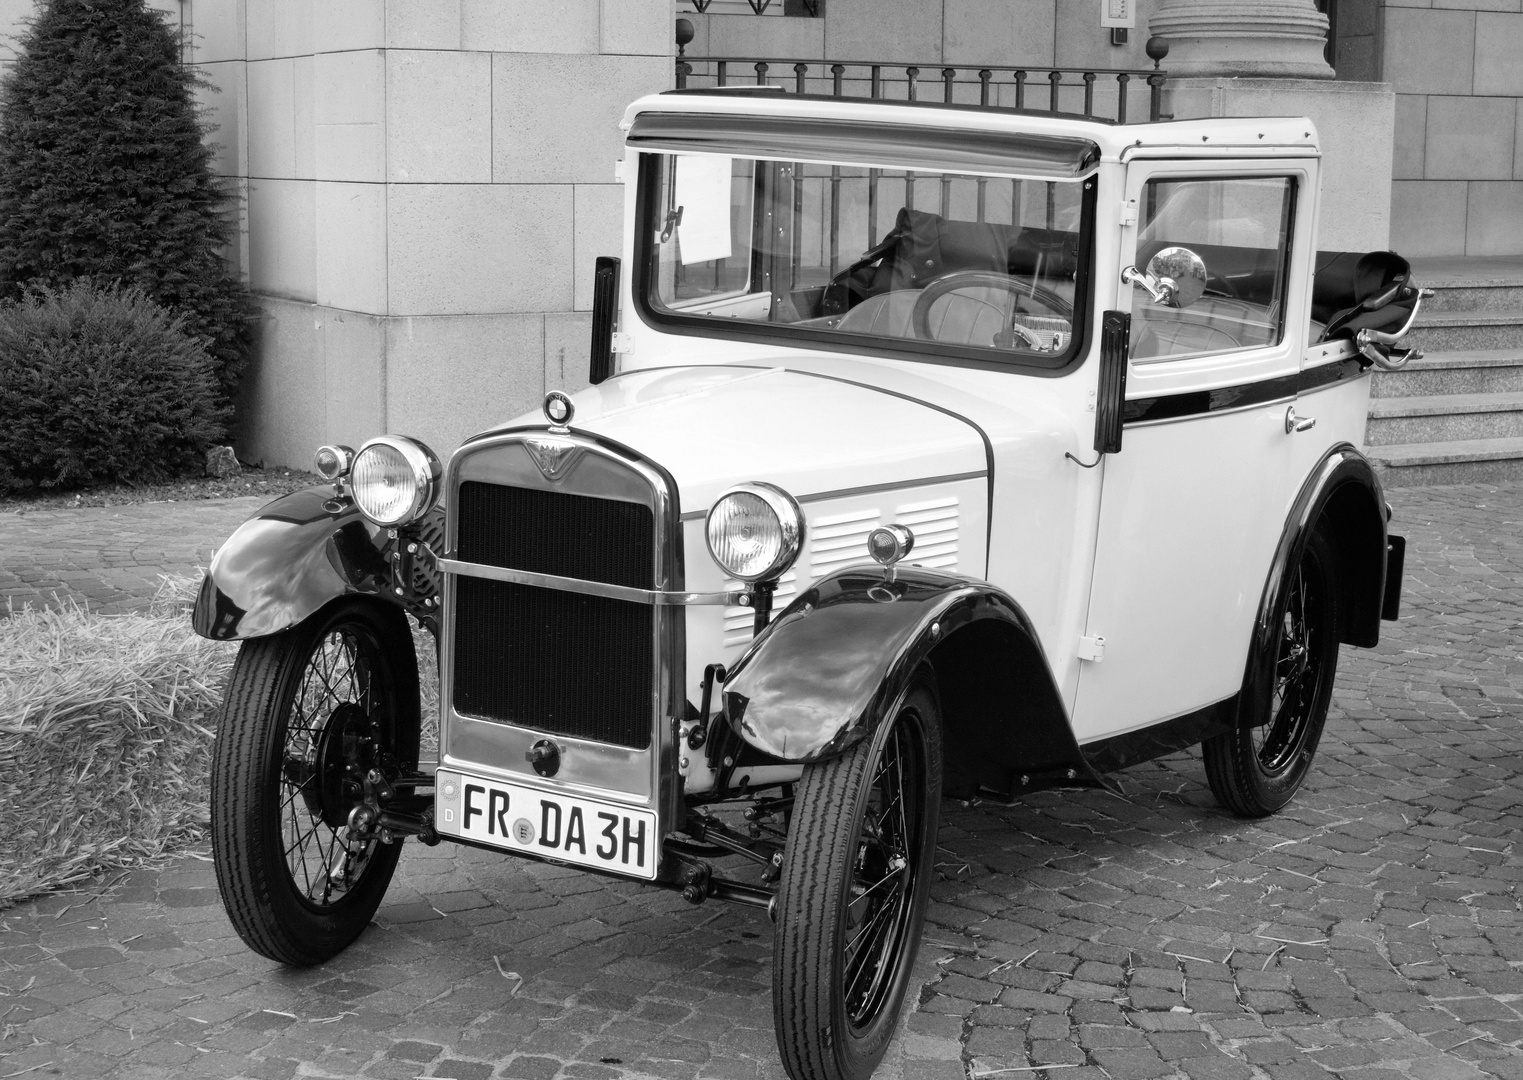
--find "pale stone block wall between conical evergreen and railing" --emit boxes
[181,0,673,466]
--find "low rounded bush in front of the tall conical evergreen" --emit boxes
[0,280,227,492]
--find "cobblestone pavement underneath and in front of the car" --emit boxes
[0,484,1523,1080]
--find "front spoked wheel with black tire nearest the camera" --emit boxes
[772,678,941,1080]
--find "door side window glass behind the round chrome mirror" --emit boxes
[1132,177,1296,361]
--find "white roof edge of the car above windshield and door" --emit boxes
[620,87,1320,161]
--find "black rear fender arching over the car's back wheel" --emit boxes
[1238,443,1403,727]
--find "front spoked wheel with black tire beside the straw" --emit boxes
[212,597,419,966]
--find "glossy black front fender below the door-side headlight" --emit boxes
[723,567,1103,792]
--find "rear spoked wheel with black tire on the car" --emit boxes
[1202,530,1339,818]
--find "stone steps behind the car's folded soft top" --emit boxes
[1365,259,1523,487]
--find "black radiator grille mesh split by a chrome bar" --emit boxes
[454,483,655,749]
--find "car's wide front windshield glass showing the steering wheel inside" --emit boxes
[641,147,1092,367]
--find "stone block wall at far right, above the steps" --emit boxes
[1381,0,1523,256]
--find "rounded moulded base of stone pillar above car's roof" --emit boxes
[1148,0,1333,79]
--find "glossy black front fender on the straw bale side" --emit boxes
[190,484,402,641]
